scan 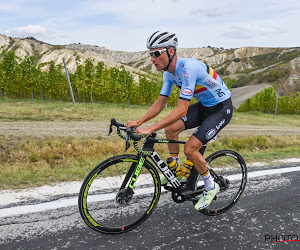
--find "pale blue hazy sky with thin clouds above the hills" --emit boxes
[0,0,300,51]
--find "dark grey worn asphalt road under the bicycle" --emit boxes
[0,163,300,250]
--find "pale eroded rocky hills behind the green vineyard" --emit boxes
[0,35,300,93]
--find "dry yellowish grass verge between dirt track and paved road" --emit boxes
[0,136,300,189]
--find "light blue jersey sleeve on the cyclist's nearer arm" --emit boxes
[179,62,197,101]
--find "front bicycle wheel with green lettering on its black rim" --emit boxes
[78,154,161,234]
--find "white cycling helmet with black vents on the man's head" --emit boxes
[147,31,178,49]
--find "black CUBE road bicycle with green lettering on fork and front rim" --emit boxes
[78,119,247,234]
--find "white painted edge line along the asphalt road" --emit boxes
[0,166,300,218]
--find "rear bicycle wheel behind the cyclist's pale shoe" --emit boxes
[192,150,247,216]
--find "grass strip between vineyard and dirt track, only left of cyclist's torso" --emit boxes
[0,98,171,122]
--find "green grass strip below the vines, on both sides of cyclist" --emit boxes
[0,98,300,127]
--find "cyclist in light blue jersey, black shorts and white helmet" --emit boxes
[126,31,233,210]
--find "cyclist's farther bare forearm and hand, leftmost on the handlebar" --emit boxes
[126,95,168,127]
